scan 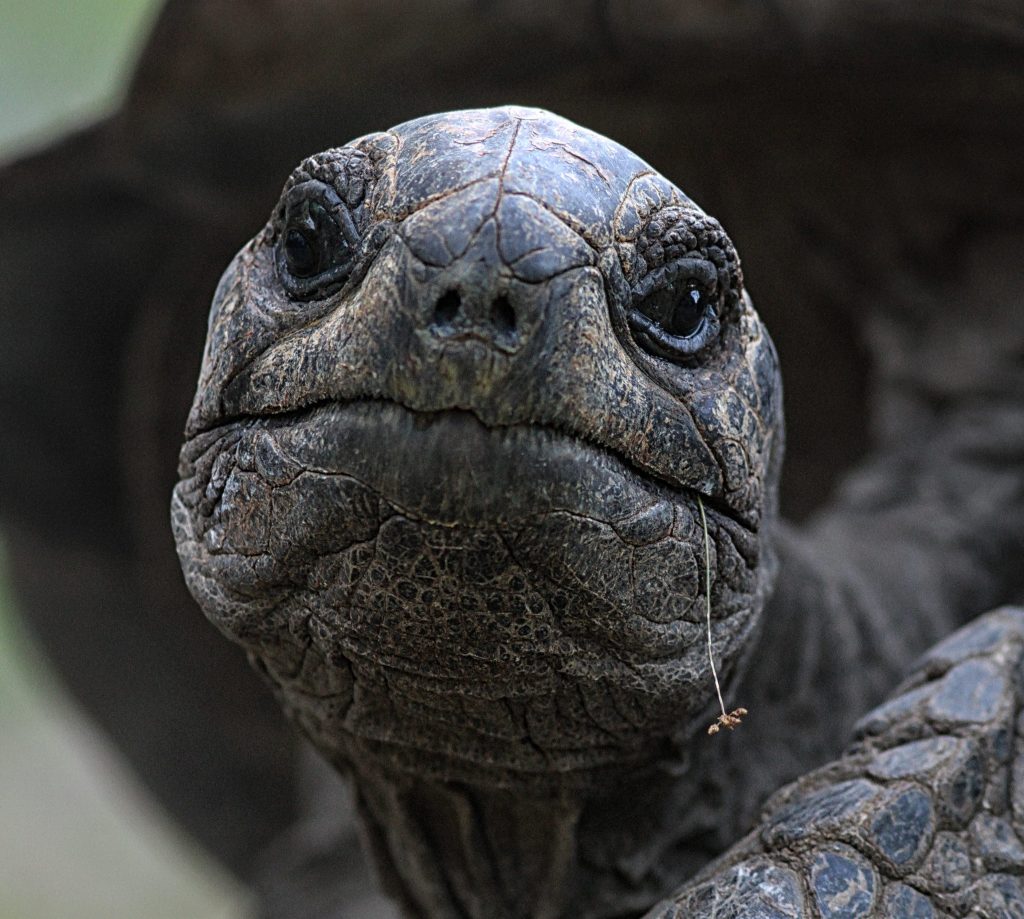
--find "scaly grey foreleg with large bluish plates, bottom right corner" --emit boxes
[648,608,1024,919]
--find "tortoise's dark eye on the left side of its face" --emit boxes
[278,181,359,300]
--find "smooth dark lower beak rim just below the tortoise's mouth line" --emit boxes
[246,400,700,527]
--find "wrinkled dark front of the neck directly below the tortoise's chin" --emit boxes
[352,745,721,919]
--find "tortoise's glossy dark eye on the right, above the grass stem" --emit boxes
[629,262,719,361]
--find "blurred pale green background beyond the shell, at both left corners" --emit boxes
[0,0,246,919]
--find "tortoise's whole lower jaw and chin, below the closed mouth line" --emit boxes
[175,393,761,781]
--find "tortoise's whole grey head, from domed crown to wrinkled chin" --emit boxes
[173,109,781,784]
